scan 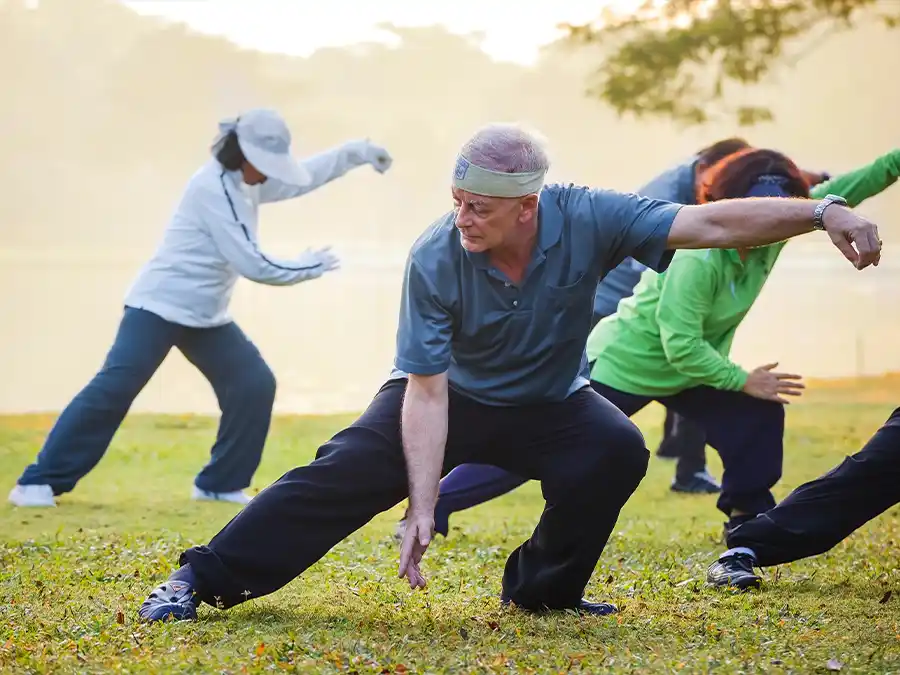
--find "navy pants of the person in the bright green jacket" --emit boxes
[422,382,784,524]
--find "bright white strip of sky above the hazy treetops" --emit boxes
[122,0,642,63]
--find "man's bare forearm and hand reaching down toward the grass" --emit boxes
[400,371,449,588]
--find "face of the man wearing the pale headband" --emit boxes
[451,187,538,253]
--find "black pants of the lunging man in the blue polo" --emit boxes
[181,380,649,609]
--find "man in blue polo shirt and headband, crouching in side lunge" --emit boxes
[139,125,881,621]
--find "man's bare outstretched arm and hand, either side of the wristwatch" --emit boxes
[668,197,881,269]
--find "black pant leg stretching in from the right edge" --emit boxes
[728,408,900,567]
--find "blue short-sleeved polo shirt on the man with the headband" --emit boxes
[392,185,681,406]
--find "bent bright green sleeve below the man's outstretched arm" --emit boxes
[656,254,747,391]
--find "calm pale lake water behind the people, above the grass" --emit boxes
[0,242,900,413]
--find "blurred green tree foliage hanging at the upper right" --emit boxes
[562,0,900,126]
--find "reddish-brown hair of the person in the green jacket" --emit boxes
[697,148,809,204]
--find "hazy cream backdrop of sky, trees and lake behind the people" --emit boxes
[0,0,900,413]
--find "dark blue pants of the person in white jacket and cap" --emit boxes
[18,307,275,495]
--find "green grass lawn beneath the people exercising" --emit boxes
[0,383,900,673]
